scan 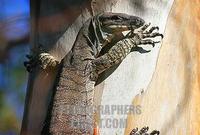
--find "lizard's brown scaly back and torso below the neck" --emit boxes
[50,27,95,135]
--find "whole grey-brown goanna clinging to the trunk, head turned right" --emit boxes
[25,13,163,135]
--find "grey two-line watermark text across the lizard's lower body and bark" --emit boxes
[61,105,142,129]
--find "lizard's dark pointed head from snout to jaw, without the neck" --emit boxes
[97,12,145,34]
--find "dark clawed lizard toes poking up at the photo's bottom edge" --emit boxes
[130,127,160,135]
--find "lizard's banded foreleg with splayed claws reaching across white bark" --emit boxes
[92,25,163,74]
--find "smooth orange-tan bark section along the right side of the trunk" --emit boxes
[126,0,200,135]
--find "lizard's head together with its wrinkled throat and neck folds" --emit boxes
[89,12,145,54]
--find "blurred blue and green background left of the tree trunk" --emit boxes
[0,0,30,135]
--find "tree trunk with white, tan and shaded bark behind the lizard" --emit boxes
[21,0,199,135]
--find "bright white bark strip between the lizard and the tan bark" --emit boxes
[94,0,173,135]
